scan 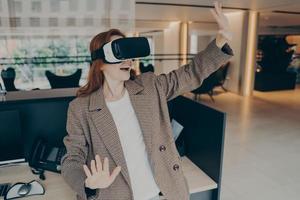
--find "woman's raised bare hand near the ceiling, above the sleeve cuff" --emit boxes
[210,1,232,48]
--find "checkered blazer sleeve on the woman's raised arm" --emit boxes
[155,39,233,101]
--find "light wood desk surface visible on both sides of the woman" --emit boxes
[0,156,217,200]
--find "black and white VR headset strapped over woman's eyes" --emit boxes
[91,37,150,64]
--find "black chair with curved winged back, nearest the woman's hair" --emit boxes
[45,69,82,89]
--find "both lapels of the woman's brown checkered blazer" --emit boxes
[89,80,154,188]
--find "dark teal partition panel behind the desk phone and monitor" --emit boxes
[0,97,74,159]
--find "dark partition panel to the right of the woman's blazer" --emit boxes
[169,96,226,200]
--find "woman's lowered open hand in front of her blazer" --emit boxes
[83,155,121,189]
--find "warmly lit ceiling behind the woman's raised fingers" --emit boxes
[135,0,300,29]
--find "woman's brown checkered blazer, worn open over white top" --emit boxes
[61,40,233,200]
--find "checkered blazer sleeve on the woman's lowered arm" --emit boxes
[61,102,88,200]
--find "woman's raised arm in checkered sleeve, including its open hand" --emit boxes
[155,2,233,100]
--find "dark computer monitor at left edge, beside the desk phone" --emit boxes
[0,110,25,165]
